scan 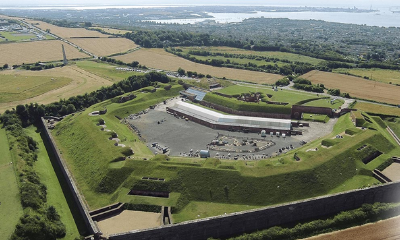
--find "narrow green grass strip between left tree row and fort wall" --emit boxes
[25,126,79,240]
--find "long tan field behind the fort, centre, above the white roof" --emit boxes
[115,49,282,84]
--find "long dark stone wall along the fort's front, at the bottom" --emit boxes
[109,182,400,240]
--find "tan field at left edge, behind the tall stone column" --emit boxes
[0,40,88,66]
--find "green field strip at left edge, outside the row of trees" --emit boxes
[0,128,23,239]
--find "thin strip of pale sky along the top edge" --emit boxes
[0,0,400,8]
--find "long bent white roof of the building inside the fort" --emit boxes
[172,102,291,130]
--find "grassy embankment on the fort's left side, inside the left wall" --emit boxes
[53,85,182,208]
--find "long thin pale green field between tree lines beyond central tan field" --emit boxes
[180,47,324,65]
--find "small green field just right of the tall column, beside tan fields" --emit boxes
[76,61,144,82]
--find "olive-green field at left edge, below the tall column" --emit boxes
[0,74,72,103]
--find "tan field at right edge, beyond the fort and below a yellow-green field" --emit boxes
[301,70,400,104]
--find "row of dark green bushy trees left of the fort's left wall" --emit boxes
[0,112,66,240]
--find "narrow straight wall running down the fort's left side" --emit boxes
[41,118,100,237]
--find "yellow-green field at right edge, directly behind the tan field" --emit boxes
[333,68,400,84]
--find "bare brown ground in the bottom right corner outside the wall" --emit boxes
[307,216,400,240]
